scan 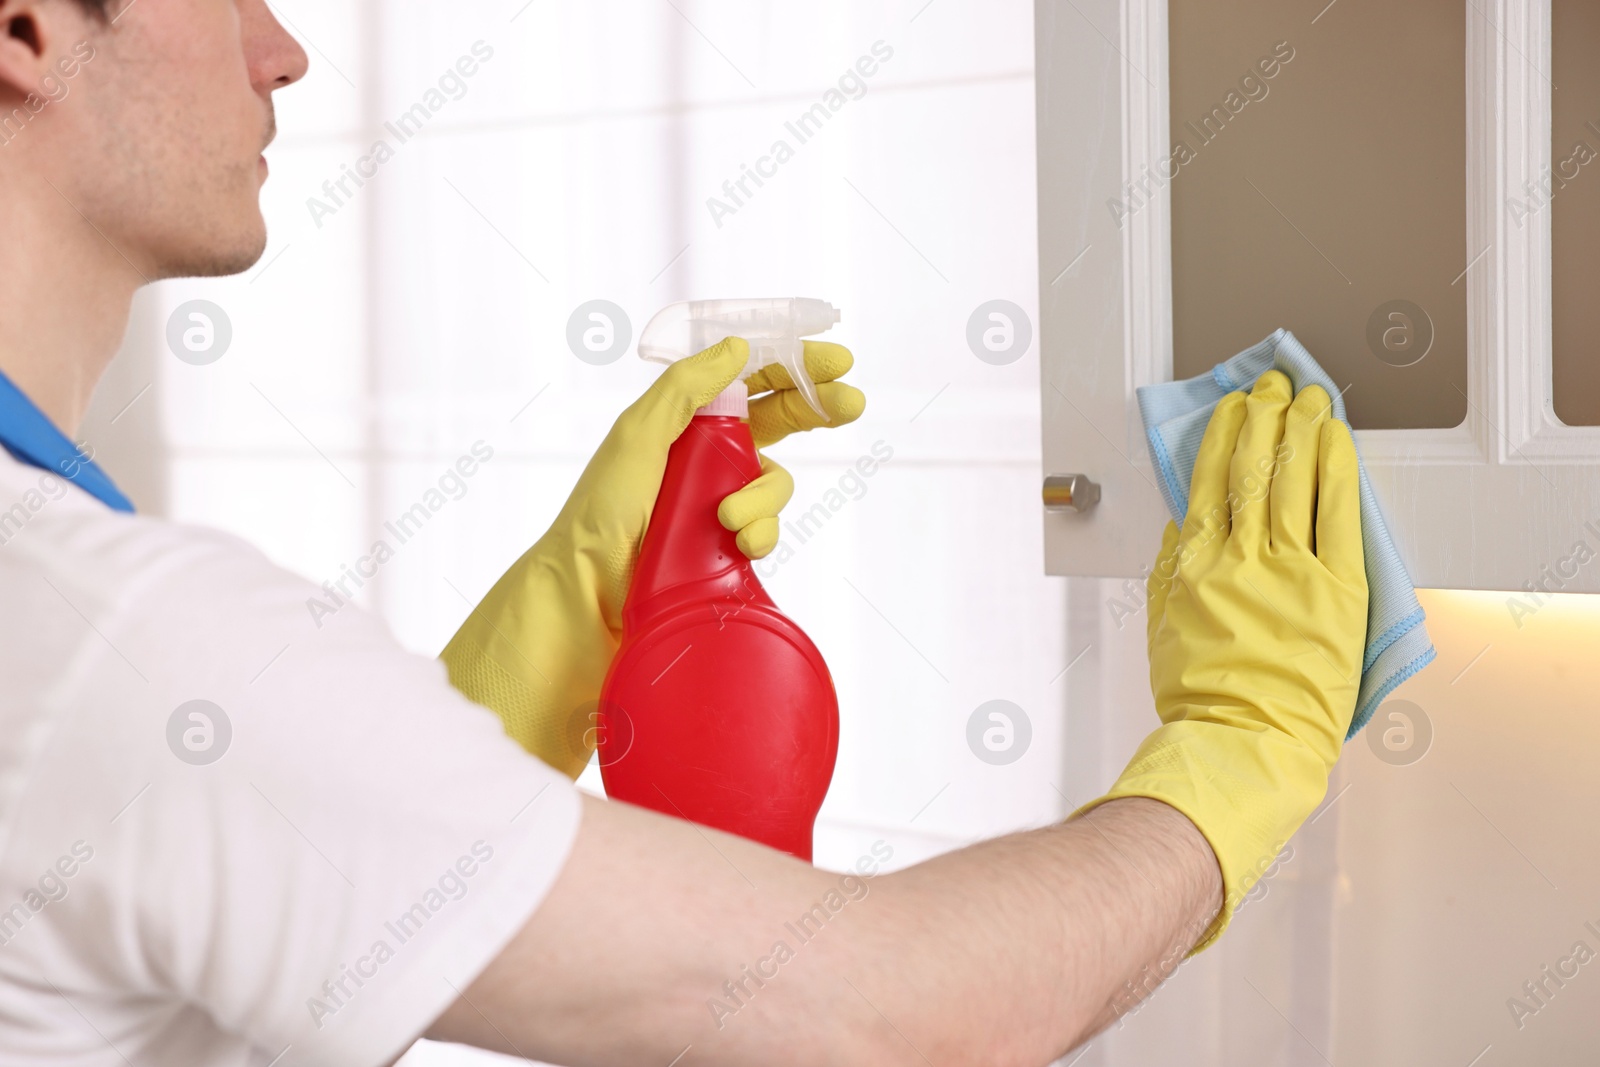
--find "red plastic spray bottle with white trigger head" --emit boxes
[598,299,838,861]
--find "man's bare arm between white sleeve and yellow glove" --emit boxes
[432,798,1221,1067]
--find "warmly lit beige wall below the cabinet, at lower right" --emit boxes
[1331,590,1600,1067]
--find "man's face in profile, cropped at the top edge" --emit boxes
[51,0,306,278]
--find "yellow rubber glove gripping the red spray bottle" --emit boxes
[440,338,866,777]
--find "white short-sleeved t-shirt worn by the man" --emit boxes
[0,451,579,1067]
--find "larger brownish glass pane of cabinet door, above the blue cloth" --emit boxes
[1171,0,1465,429]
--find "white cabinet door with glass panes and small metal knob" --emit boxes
[1035,0,1600,592]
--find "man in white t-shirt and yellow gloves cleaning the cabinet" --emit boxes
[0,0,1366,1067]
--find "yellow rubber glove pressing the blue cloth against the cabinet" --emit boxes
[1088,371,1366,952]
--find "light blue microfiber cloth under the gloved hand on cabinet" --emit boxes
[1139,330,1435,741]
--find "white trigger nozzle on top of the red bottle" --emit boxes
[638,298,840,422]
